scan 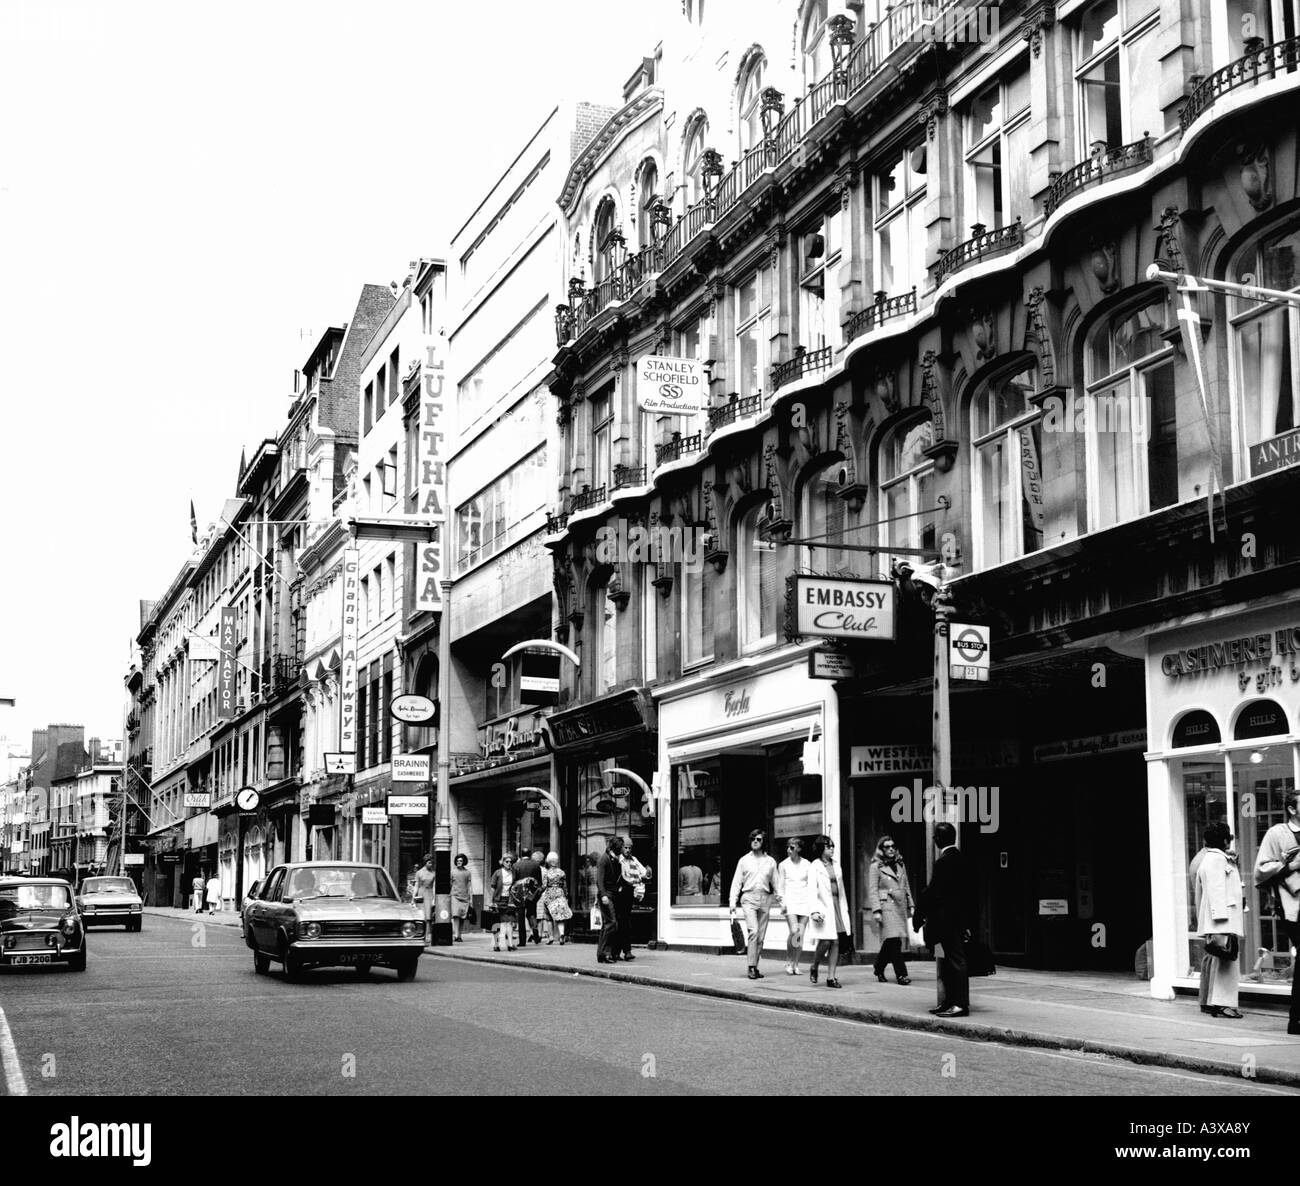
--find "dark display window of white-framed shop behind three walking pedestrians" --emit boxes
[672,741,823,906]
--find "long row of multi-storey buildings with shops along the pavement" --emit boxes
[114,0,1300,996]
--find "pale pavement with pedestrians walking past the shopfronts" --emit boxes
[426,934,1300,1087]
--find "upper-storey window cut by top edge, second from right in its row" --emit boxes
[1075,0,1165,151]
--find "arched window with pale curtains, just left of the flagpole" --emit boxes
[1083,291,1178,531]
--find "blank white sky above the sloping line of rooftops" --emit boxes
[0,0,672,744]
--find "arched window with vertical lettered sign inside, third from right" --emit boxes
[971,364,1047,568]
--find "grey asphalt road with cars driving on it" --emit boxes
[0,916,1297,1098]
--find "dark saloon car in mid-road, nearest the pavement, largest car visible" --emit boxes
[242,861,424,981]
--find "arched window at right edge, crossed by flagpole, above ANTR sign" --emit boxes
[1229,224,1300,477]
